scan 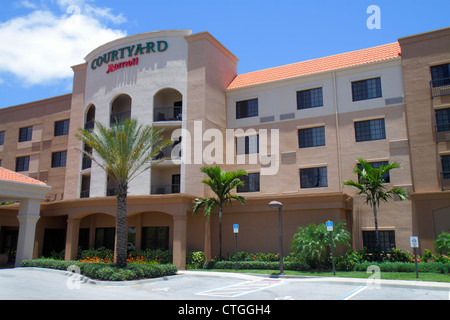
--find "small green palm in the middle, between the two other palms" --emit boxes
[193,166,247,259]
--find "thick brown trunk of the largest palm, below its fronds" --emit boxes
[115,188,128,268]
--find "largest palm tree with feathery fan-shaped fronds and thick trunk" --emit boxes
[75,119,169,268]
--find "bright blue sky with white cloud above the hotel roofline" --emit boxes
[0,0,450,108]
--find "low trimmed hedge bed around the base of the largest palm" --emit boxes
[20,259,178,281]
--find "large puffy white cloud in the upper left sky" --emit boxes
[0,0,126,86]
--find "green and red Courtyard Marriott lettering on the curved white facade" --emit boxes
[91,40,169,73]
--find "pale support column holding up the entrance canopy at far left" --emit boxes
[15,199,41,267]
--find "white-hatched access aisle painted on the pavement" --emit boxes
[196,279,283,298]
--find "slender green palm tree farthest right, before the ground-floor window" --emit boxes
[344,158,407,251]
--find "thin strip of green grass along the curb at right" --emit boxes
[195,269,450,282]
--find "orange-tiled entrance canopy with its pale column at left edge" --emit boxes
[0,167,51,266]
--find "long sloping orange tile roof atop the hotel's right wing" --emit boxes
[227,42,401,90]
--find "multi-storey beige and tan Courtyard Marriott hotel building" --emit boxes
[0,28,450,269]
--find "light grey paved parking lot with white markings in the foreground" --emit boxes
[0,268,450,301]
